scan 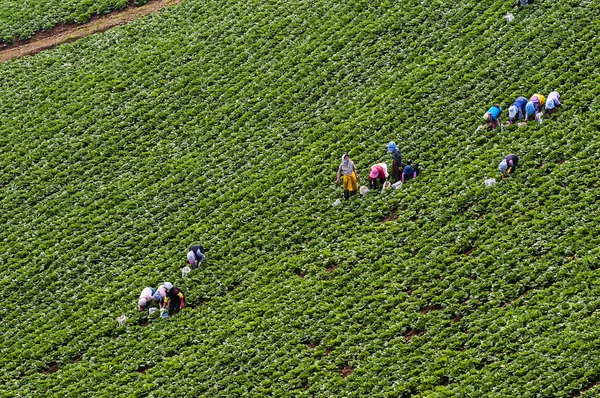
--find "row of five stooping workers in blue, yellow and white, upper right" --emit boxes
[483,91,560,129]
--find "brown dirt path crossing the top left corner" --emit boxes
[0,0,183,63]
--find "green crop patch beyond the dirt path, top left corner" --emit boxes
[0,0,137,43]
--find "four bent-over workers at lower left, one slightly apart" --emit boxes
[138,245,206,318]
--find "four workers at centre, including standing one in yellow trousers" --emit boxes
[335,141,418,199]
